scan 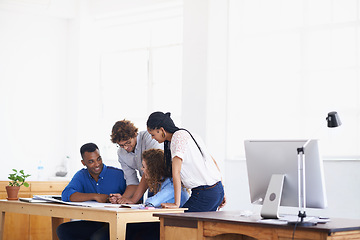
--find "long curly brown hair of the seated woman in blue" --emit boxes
[142,149,171,194]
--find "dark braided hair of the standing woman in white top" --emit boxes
[146,112,203,172]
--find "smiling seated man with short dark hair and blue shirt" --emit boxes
[56,143,126,240]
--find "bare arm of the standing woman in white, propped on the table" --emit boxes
[161,157,182,208]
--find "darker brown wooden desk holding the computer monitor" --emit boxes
[154,211,360,240]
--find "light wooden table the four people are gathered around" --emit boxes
[0,200,185,240]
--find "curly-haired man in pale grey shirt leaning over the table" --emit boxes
[111,119,163,203]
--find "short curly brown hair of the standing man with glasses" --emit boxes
[111,119,138,143]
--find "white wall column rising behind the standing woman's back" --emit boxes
[182,0,228,172]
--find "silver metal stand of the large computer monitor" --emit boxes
[261,174,285,219]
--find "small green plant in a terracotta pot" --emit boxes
[6,169,30,200]
